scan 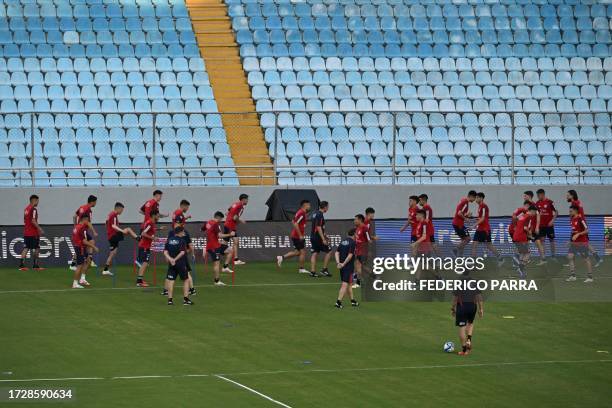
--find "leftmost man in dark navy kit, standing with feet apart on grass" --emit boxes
[164,227,193,306]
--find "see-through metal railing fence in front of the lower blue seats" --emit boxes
[0,111,612,187]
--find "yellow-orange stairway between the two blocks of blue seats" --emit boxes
[186,0,274,185]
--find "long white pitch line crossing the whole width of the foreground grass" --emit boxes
[0,359,612,382]
